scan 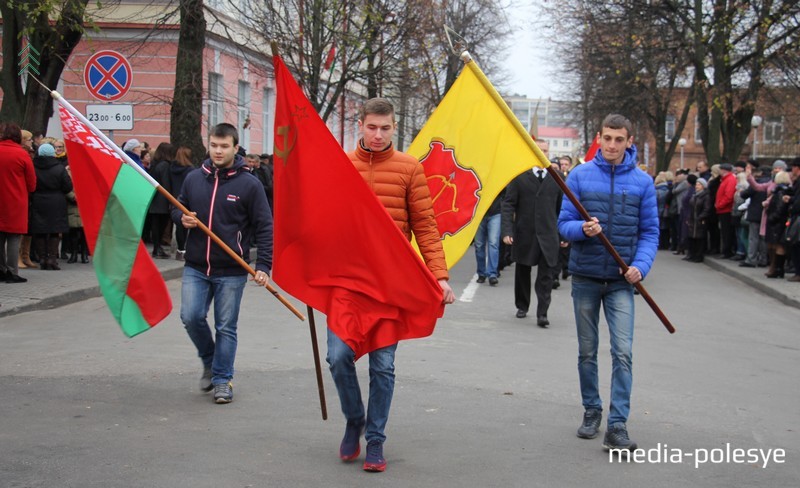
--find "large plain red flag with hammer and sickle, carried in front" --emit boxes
[273,56,444,358]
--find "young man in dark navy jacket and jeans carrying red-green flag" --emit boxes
[172,124,272,403]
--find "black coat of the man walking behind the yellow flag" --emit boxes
[501,171,563,267]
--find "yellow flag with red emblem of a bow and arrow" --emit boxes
[408,55,550,269]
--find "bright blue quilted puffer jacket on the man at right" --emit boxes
[558,146,658,280]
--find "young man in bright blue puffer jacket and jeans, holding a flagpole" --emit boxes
[558,114,658,450]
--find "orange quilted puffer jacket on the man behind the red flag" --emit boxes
[347,144,449,280]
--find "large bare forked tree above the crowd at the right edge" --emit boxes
[660,0,800,164]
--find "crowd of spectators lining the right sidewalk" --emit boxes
[654,158,800,283]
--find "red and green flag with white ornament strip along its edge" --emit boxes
[59,106,172,337]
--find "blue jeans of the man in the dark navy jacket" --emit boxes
[181,266,247,385]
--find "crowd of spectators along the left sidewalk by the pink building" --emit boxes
[0,123,272,283]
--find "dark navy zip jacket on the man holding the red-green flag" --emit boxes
[172,155,272,276]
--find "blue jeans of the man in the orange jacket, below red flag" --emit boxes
[326,329,397,442]
